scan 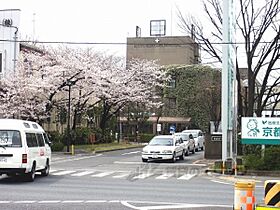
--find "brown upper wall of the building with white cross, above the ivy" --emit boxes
[126,36,200,65]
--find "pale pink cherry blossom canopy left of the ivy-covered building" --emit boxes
[0,47,167,139]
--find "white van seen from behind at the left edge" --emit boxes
[0,119,51,181]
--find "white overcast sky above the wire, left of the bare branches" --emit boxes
[1,0,205,54]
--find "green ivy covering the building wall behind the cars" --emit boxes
[164,65,221,131]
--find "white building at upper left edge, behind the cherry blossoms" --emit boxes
[0,9,20,78]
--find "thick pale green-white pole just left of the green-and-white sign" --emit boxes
[222,0,237,162]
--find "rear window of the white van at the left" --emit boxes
[0,130,22,147]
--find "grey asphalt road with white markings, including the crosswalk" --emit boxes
[0,149,263,210]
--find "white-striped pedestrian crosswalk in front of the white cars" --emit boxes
[47,169,196,180]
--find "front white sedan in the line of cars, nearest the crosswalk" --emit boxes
[142,135,184,162]
